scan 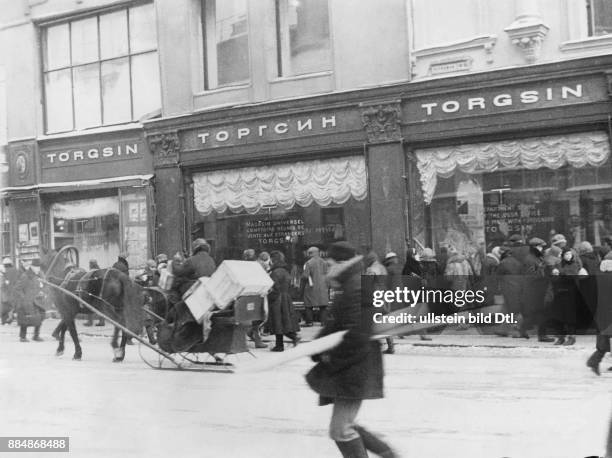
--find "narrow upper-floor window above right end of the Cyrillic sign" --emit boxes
[276,0,332,76]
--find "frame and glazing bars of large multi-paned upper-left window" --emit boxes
[40,0,161,135]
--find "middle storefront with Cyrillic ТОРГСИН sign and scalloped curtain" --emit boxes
[147,98,412,280]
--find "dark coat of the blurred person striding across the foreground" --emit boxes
[306,256,383,405]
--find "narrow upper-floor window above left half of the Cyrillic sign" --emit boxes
[202,0,250,89]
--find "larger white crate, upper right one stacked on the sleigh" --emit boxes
[206,261,274,309]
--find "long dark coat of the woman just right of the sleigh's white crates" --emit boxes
[268,263,300,334]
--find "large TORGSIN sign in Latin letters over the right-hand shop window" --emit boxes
[407,79,607,121]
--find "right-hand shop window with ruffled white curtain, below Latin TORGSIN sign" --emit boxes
[416,132,612,254]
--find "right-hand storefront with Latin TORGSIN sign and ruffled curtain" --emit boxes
[404,55,612,255]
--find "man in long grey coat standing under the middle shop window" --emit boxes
[302,246,329,326]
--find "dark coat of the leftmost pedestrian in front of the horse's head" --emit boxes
[14,269,46,326]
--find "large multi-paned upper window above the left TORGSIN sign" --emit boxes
[42,3,161,133]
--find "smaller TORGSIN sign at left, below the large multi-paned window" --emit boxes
[41,141,144,168]
